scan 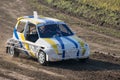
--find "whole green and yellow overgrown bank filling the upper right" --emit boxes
[39,0,120,29]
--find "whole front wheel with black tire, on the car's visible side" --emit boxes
[38,51,47,66]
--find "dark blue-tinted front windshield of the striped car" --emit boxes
[38,24,73,38]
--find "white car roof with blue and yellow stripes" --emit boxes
[18,16,64,25]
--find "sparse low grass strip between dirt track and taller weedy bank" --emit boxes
[28,0,120,38]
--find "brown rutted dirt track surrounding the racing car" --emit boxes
[0,0,120,80]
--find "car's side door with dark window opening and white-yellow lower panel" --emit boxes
[24,22,39,57]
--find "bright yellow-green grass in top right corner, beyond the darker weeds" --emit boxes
[78,0,120,11]
